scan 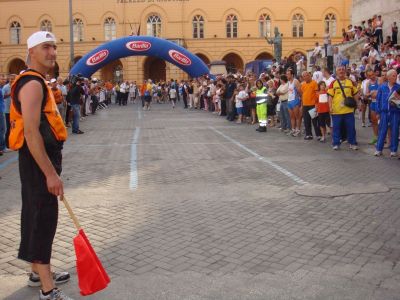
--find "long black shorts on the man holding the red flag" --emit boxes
[18,143,62,264]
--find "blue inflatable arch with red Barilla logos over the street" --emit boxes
[70,36,210,78]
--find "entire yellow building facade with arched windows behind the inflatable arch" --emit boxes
[0,0,352,81]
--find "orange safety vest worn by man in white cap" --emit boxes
[9,70,67,150]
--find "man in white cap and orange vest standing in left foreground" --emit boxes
[9,31,72,300]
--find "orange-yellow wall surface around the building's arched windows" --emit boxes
[0,0,351,80]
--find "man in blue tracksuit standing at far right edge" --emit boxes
[375,70,400,157]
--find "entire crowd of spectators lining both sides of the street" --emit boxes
[0,16,400,157]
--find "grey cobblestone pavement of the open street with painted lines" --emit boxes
[0,104,400,300]
